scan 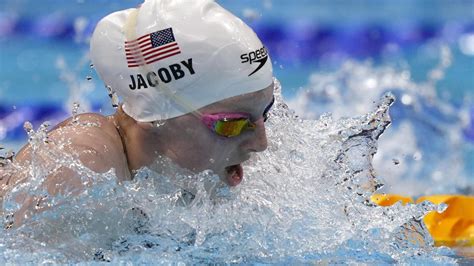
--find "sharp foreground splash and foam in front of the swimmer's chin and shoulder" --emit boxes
[0,77,462,264]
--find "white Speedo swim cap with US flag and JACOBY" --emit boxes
[91,0,272,122]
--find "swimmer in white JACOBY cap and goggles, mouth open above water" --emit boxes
[0,0,273,223]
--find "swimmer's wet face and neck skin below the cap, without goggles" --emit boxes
[114,86,273,185]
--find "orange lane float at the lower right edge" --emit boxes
[371,194,474,246]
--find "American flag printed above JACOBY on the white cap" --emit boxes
[125,28,181,67]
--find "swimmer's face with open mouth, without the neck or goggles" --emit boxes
[156,85,273,186]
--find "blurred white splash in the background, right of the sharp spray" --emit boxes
[289,46,474,196]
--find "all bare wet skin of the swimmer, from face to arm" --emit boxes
[0,85,273,225]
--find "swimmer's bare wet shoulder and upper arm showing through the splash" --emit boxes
[0,114,131,226]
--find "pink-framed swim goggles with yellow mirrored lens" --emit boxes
[201,97,275,138]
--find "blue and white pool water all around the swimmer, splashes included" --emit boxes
[0,0,474,264]
